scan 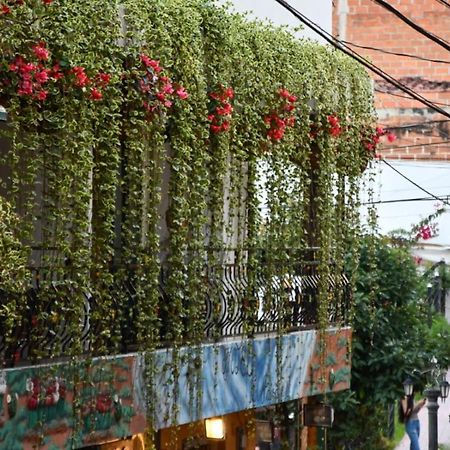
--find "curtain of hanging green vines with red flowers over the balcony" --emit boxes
[0,0,384,442]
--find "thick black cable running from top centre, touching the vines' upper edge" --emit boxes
[275,0,450,118]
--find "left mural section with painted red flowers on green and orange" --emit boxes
[0,357,145,450]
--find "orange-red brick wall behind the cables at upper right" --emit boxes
[333,0,450,161]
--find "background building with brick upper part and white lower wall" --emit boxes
[333,0,450,261]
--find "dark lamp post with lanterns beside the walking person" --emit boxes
[403,357,450,450]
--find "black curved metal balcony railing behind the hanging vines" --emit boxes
[0,256,350,365]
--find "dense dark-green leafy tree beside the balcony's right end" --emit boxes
[331,237,430,450]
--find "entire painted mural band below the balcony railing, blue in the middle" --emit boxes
[0,328,351,450]
